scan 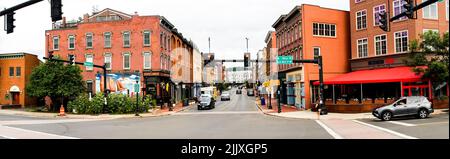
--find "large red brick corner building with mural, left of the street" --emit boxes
[46,8,197,102]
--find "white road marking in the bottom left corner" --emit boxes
[0,125,78,139]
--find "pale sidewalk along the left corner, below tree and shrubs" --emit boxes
[0,104,193,120]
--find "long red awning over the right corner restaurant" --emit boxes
[314,67,422,85]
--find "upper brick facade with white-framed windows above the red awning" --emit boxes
[350,0,449,71]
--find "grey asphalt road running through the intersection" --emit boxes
[0,87,449,139]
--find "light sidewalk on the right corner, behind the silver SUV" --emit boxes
[256,100,448,120]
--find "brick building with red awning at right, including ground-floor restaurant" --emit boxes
[318,0,449,112]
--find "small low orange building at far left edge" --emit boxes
[0,53,40,109]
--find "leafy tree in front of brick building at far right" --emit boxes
[406,31,449,95]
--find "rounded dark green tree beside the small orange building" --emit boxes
[25,61,86,110]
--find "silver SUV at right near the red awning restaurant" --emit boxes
[372,96,434,121]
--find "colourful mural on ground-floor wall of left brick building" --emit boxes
[95,73,142,94]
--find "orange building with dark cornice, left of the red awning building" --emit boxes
[272,4,351,109]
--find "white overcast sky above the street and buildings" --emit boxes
[0,0,349,66]
